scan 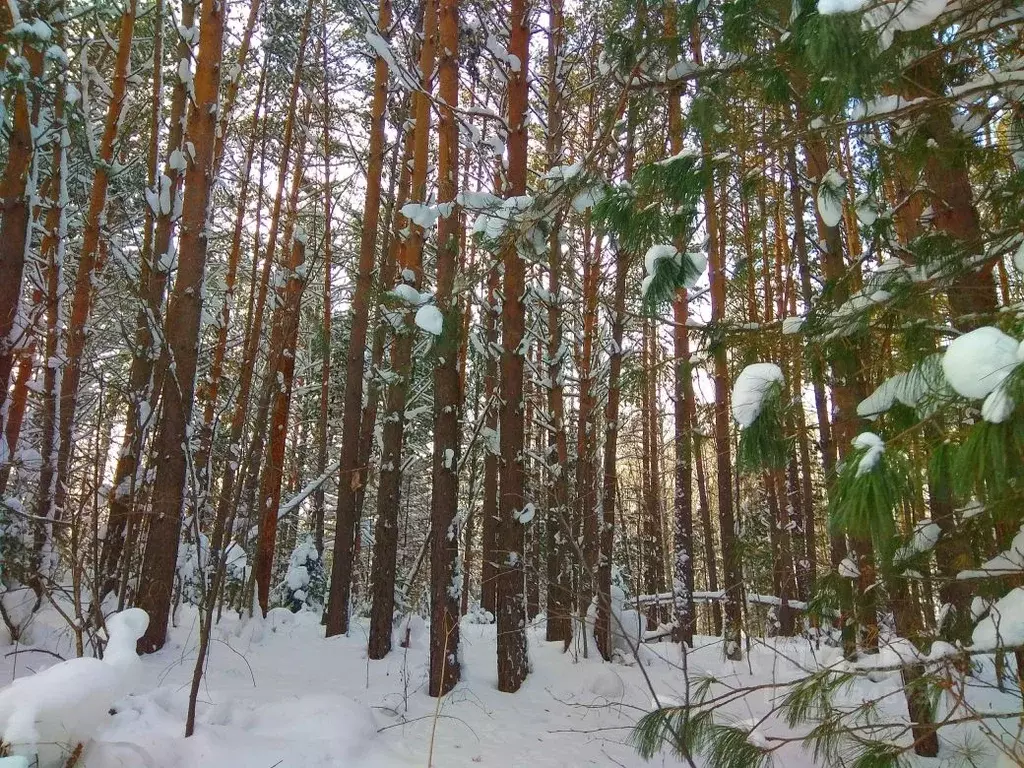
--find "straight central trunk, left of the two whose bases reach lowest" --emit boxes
[429,0,463,696]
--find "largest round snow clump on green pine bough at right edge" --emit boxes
[942,326,1021,400]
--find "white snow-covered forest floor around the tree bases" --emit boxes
[0,608,1019,768]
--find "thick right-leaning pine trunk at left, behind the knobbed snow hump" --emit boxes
[138,0,228,653]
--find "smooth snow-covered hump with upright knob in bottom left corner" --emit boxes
[0,608,150,768]
